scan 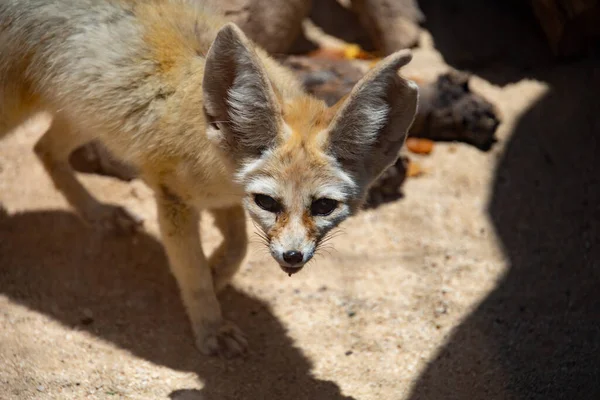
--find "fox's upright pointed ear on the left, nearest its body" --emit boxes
[203,23,281,161]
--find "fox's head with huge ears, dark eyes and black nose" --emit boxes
[203,24,418,274]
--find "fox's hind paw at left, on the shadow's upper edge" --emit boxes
[84,204,144,234]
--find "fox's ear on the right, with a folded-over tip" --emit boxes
[328,50,419,186]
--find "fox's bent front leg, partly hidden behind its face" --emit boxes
[208,205,248,292]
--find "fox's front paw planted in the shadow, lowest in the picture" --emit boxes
[196,321,248,358]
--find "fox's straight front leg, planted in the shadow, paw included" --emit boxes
[157,189,247,357]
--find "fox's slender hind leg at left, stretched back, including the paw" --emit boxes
[35,117,142,232]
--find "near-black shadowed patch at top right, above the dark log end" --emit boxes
[418,0,553,85]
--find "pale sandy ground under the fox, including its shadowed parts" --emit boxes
[0,2,600,400]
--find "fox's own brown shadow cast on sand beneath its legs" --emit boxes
[0,211,350,400]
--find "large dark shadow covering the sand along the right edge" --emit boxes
[410,23,600,400]
